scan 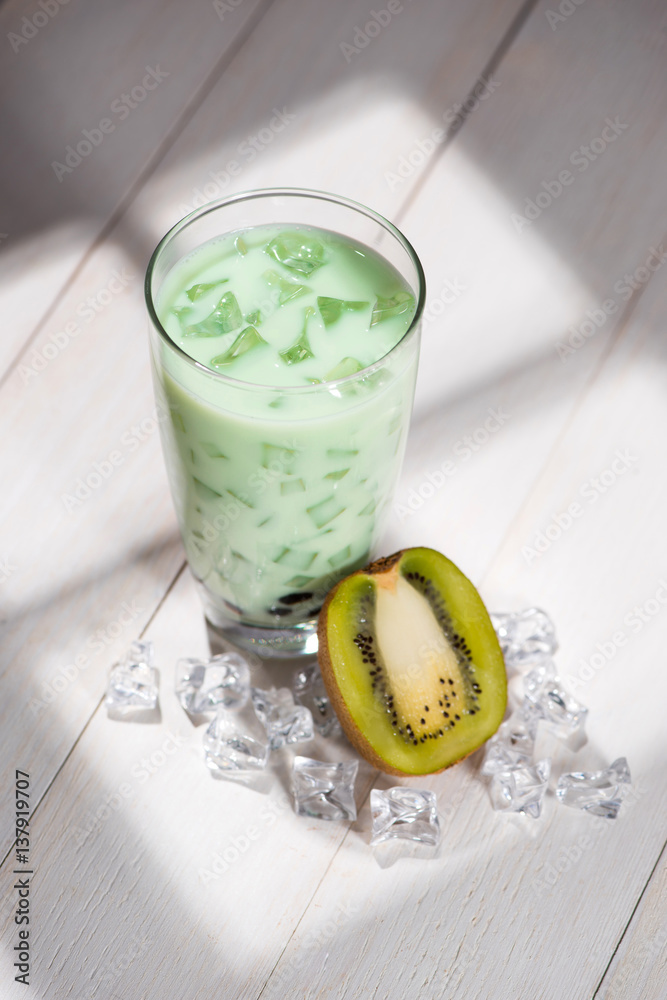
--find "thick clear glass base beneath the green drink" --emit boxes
[198,584,317,659]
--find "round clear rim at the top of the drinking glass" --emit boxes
[144,188,426,395]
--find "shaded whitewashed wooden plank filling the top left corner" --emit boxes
[0,0,274,373]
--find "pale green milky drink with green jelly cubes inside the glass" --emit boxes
[154,225,417,628]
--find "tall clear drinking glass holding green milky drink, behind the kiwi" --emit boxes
[146,189,425,656]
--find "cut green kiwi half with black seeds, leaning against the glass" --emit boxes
[318,548,507,774]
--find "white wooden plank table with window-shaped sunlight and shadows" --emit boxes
[0,0,667,1000]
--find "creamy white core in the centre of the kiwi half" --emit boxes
[375,574,463,734]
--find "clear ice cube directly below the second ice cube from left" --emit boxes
[204,705,269,774]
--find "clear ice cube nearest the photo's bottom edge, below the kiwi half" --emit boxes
[371,785,440,847]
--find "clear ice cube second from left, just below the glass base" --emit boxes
[176,653,250,715]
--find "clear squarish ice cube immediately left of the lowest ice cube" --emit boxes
[292,757,359,820]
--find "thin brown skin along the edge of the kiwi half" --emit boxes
[318,547,505,777]
